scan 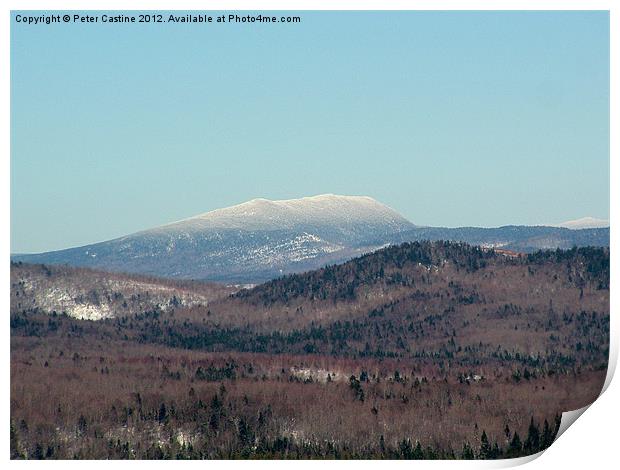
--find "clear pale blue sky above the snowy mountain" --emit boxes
[11,11,609,253]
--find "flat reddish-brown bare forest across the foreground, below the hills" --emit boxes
[11,317,605,459]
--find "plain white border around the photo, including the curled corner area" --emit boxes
[0,0,620,469]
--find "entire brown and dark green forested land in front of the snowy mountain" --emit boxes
[10,242,609,458]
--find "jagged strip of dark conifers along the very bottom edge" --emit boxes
[10,416,560,460]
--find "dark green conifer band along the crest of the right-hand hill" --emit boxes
[233,241,609,306]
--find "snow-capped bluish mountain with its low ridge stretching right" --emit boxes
[11,194,609,284]
